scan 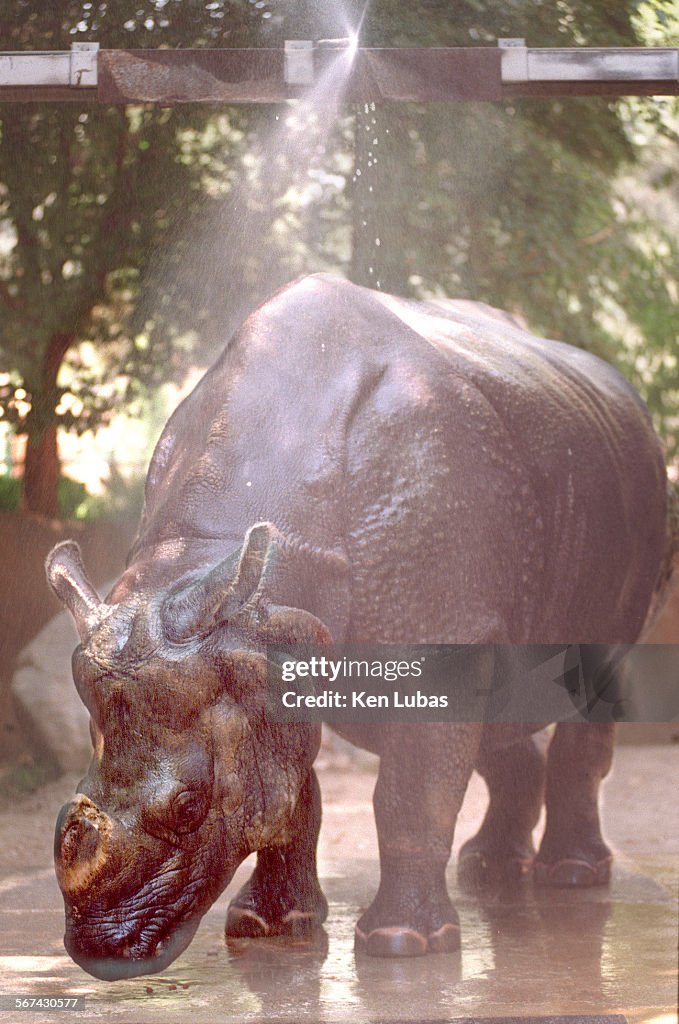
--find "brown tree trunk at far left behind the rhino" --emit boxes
[22,332,76,519]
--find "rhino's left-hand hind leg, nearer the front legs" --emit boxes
[458,733,545,889]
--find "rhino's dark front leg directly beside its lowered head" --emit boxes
[225,769,328,938]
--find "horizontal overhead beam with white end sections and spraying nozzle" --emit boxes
[0,37,679,106]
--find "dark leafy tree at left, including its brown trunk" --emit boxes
[0,0,272,516]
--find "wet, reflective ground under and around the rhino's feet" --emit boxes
[0,745,679,1024]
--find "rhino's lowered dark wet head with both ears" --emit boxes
[47,523,330,980]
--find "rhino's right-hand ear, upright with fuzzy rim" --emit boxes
[163,522,282,642]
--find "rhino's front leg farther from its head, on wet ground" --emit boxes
[356,723,481,956]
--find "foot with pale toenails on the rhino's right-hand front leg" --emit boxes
[355,864,460,957]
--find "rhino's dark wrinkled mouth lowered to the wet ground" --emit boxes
[63,913,203,981]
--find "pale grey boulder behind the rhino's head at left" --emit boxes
[11,584,113,774]
